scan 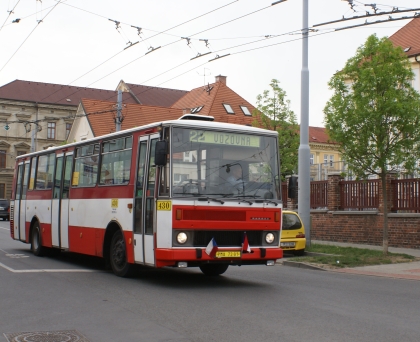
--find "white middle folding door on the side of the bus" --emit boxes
[51,153,73,249]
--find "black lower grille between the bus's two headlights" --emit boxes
[193,230,262,247]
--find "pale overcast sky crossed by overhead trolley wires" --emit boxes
[0,0,420,126]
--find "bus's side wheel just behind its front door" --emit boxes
[109,230,134,277]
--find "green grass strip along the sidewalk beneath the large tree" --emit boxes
[289,244,420,268]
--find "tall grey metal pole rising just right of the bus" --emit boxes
[298,0,311,247]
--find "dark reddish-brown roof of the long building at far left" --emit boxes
[0,80,136,106]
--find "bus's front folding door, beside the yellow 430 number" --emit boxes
[134,134,159,265]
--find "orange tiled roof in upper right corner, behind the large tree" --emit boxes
[389,17,420,57]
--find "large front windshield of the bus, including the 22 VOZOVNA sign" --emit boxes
[171,127,280,199]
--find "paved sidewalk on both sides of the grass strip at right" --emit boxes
[284,240,420,280]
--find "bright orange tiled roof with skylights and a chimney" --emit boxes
[172,81,255,125]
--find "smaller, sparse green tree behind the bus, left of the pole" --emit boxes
[253,79,300,180]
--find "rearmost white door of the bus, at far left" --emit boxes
[14,161,30,241]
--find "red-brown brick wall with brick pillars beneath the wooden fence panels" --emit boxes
[287,174,420,248]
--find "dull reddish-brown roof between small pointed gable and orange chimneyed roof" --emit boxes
[126,83,188,107]
